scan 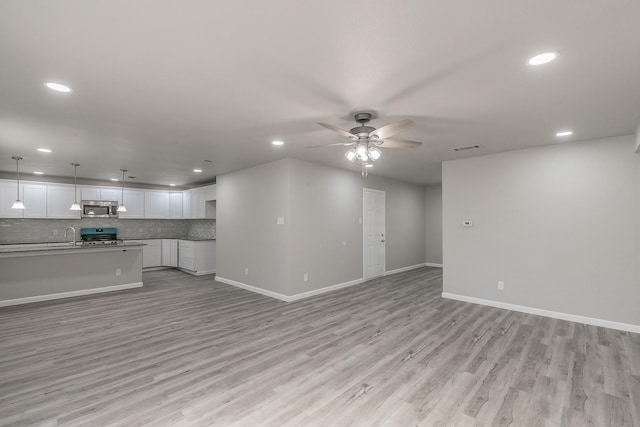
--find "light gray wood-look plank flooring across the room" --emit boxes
[0,267,640,427]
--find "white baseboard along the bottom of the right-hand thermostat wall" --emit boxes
[442,292,640,333]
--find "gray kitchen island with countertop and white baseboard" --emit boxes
[0,243,144,307]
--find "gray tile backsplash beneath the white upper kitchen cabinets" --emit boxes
[0,218,216,244]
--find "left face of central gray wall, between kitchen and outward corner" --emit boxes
[216,160,289,295]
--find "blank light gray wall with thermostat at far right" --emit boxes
[443,136,640,325]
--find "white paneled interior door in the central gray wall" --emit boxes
[362,188,386,279]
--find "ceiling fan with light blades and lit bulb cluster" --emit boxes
[307,112,422,176]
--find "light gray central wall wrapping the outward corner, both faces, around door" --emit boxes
[216,159,425,296]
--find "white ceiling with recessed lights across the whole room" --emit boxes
[0,0,640,185]
